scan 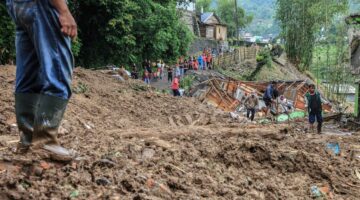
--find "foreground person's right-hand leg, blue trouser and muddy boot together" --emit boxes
[29,1,74,159]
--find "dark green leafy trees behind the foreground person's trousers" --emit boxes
[0,0,192,67]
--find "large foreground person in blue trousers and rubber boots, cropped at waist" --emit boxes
[6,0,77,159]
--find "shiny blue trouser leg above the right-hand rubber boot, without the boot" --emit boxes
[31,1,74,100]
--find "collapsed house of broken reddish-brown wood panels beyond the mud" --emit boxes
[189,72,331,112]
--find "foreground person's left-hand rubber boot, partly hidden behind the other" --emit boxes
[15,93,40,153]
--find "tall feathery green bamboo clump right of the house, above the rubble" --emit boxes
[277,0,348,70]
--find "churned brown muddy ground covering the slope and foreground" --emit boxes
[0,66,360,200]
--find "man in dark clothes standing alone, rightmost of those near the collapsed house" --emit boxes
[305,84,330,134]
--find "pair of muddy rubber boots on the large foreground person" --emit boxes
[15,93,74,161]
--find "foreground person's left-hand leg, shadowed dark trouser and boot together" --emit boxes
[7,1,41,153]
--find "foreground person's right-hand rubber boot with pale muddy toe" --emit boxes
[33,95,74,161]
